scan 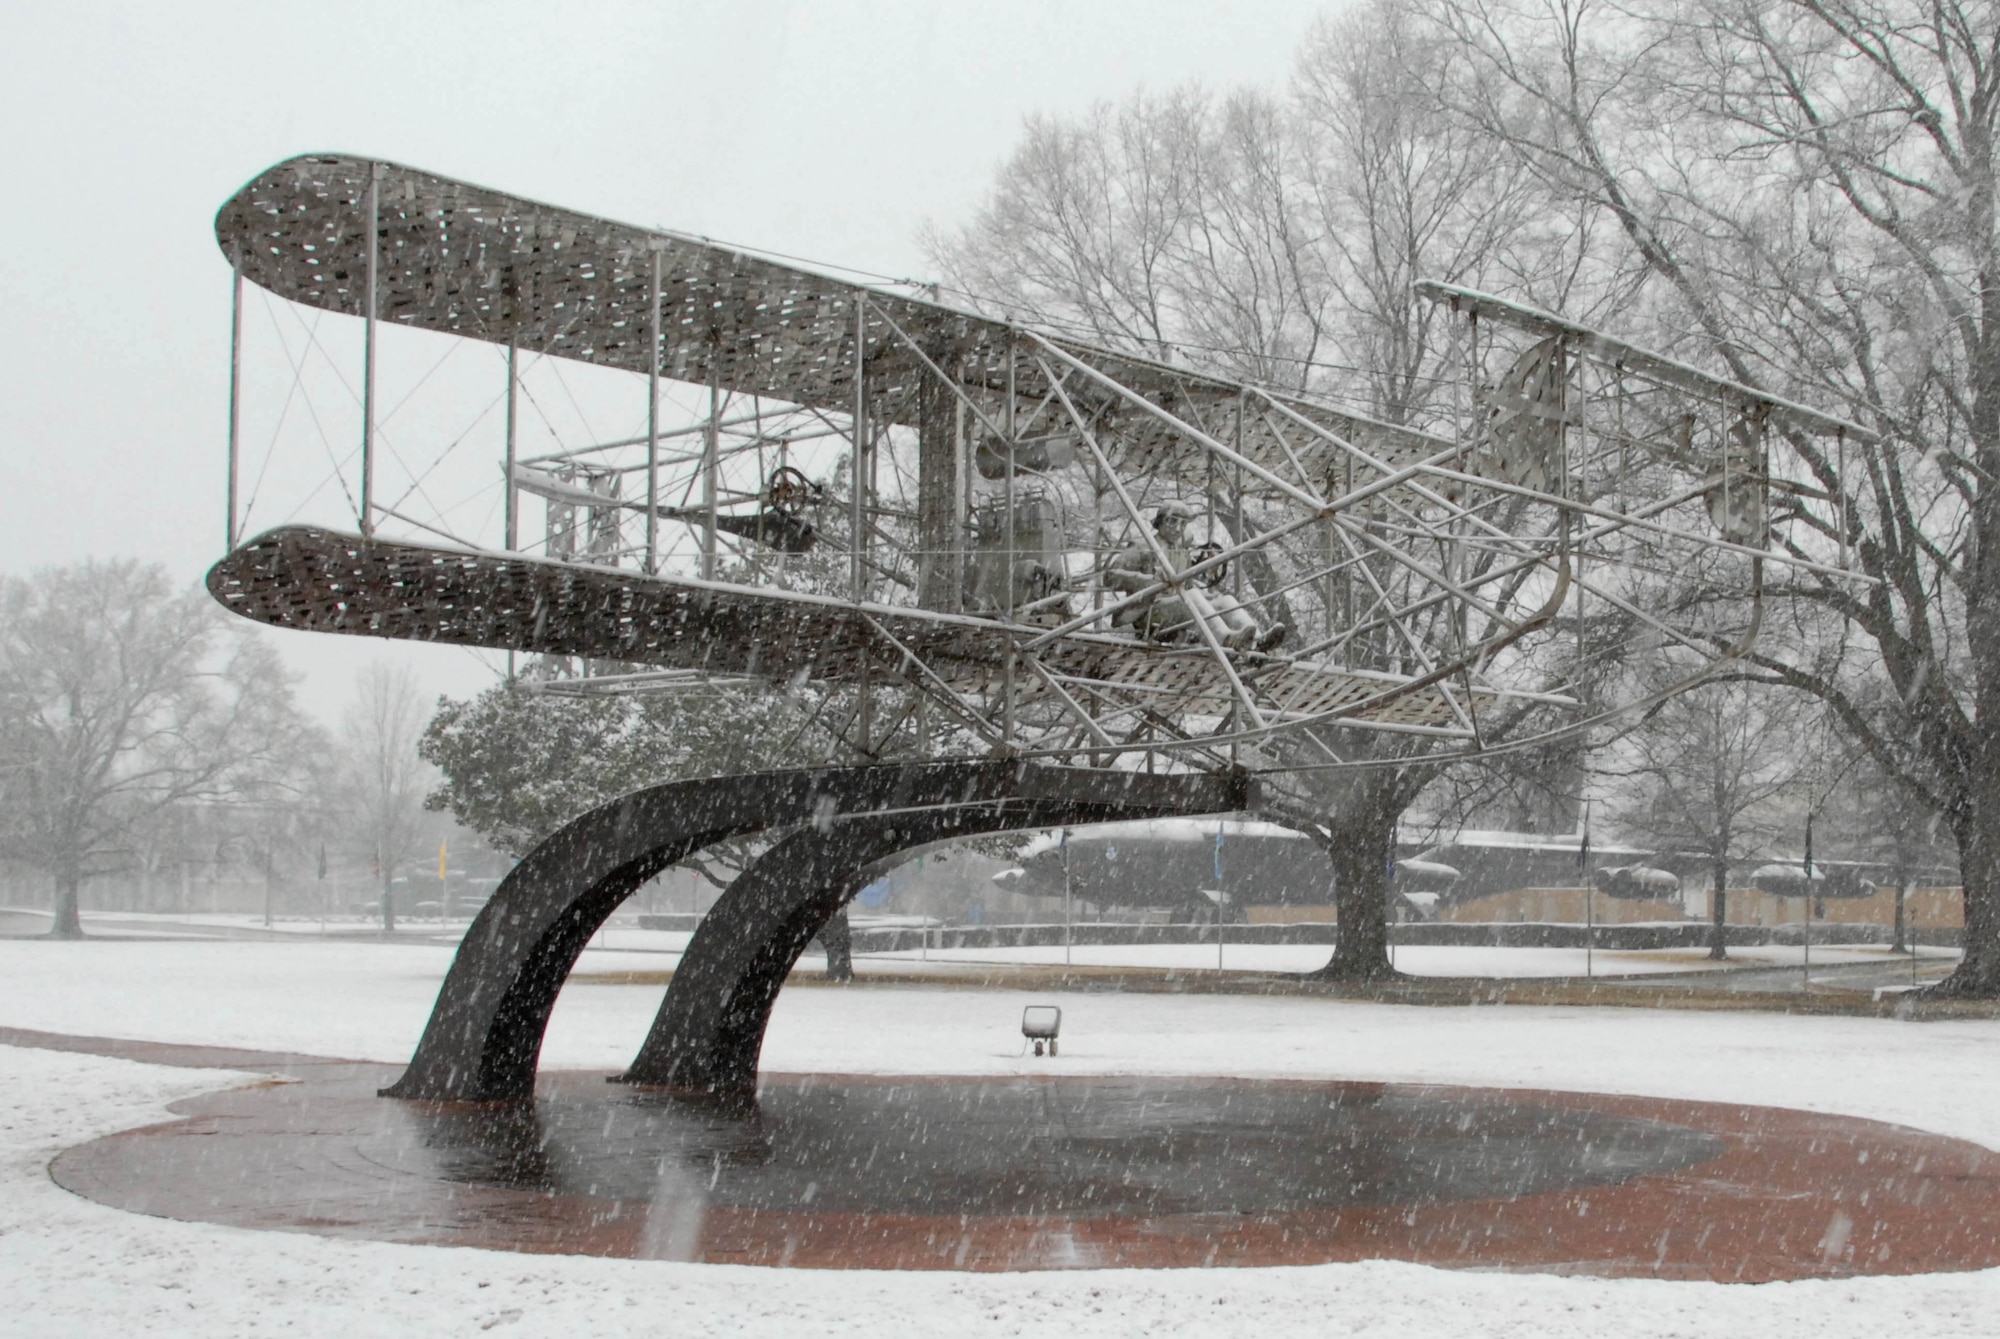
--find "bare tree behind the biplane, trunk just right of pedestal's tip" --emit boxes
[930,4,1590,979]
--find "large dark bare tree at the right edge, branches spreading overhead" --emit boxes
[1430,0,2000,995]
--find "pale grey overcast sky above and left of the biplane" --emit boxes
[0,0,1330,711]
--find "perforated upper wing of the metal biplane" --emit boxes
[216,154,1448,488]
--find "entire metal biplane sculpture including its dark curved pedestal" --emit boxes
[208,156,1866,1097]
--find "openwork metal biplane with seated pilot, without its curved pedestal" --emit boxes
[210,156,1866,767]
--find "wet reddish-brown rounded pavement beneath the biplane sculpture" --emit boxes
[35,1035,2000,1281]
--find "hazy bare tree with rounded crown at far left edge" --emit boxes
[0,562,312,937]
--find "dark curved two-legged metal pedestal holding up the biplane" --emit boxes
[382,759,1250,1101]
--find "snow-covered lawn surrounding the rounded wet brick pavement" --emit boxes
[0,933,2000,1339]
